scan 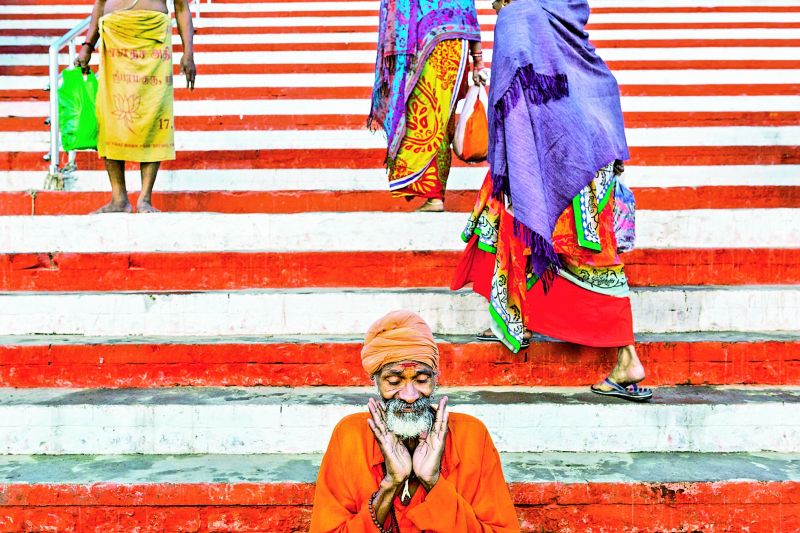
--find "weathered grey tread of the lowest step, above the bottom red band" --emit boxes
[0,452,800,485]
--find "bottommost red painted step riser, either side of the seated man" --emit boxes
[0,481,800,533]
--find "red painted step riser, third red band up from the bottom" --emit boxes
[0,248,800,291]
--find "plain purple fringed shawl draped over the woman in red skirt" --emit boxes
[489,0,628,287]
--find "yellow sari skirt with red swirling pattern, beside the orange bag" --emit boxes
[387,39,468,199]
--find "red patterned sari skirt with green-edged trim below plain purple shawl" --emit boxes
[451,163,633,352]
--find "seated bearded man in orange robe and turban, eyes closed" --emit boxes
[311,311,519,533]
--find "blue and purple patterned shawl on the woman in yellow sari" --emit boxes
[367,0,481,158]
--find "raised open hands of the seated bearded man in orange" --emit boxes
[367,396,448,491]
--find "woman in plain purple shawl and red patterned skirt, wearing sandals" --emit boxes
[451,0,652,401]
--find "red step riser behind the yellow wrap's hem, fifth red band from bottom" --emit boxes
[0,146,800,171]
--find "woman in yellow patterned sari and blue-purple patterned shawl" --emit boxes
[368,0,484,212]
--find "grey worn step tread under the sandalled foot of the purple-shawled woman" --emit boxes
[0,385,800,404]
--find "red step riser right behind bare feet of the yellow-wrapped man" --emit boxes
[0,184,800,216]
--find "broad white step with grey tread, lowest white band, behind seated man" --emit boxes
[0,387,800,455]
